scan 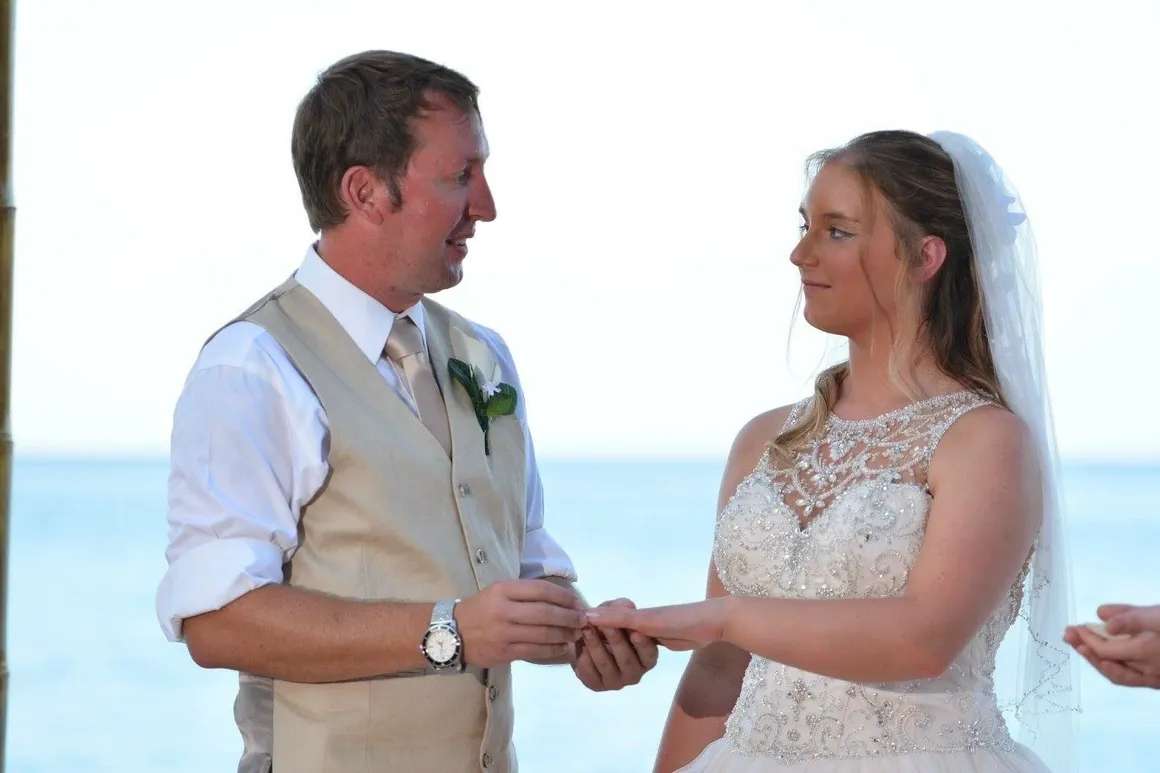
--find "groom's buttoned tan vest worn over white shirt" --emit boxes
[222,279,527,773]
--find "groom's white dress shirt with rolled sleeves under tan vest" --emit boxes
[157,247,577,642]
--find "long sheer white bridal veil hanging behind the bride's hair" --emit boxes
[930,131,1079,773]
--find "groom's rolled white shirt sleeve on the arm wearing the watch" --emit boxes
[157,323,326,642]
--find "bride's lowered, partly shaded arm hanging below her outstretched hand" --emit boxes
[653,643,749,773]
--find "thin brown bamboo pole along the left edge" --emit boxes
[0,0,16,773]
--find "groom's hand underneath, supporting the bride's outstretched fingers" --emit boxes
[572,599,658,693]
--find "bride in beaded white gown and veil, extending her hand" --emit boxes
[589,131,1076,773]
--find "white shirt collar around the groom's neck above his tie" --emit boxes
[295,245,427,363]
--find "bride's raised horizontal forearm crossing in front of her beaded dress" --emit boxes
[720,589,959,681]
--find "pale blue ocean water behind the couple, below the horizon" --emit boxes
[6,460,1160,773]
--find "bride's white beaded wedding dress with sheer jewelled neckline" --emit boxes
[682,392,1047,773]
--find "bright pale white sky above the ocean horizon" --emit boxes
[13,0,1160,458]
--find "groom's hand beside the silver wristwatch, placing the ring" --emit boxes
[455,579,588,669]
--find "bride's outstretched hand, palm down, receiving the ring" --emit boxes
[587,597,727,651]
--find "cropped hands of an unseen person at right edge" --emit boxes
[1064,604,1160,689]
